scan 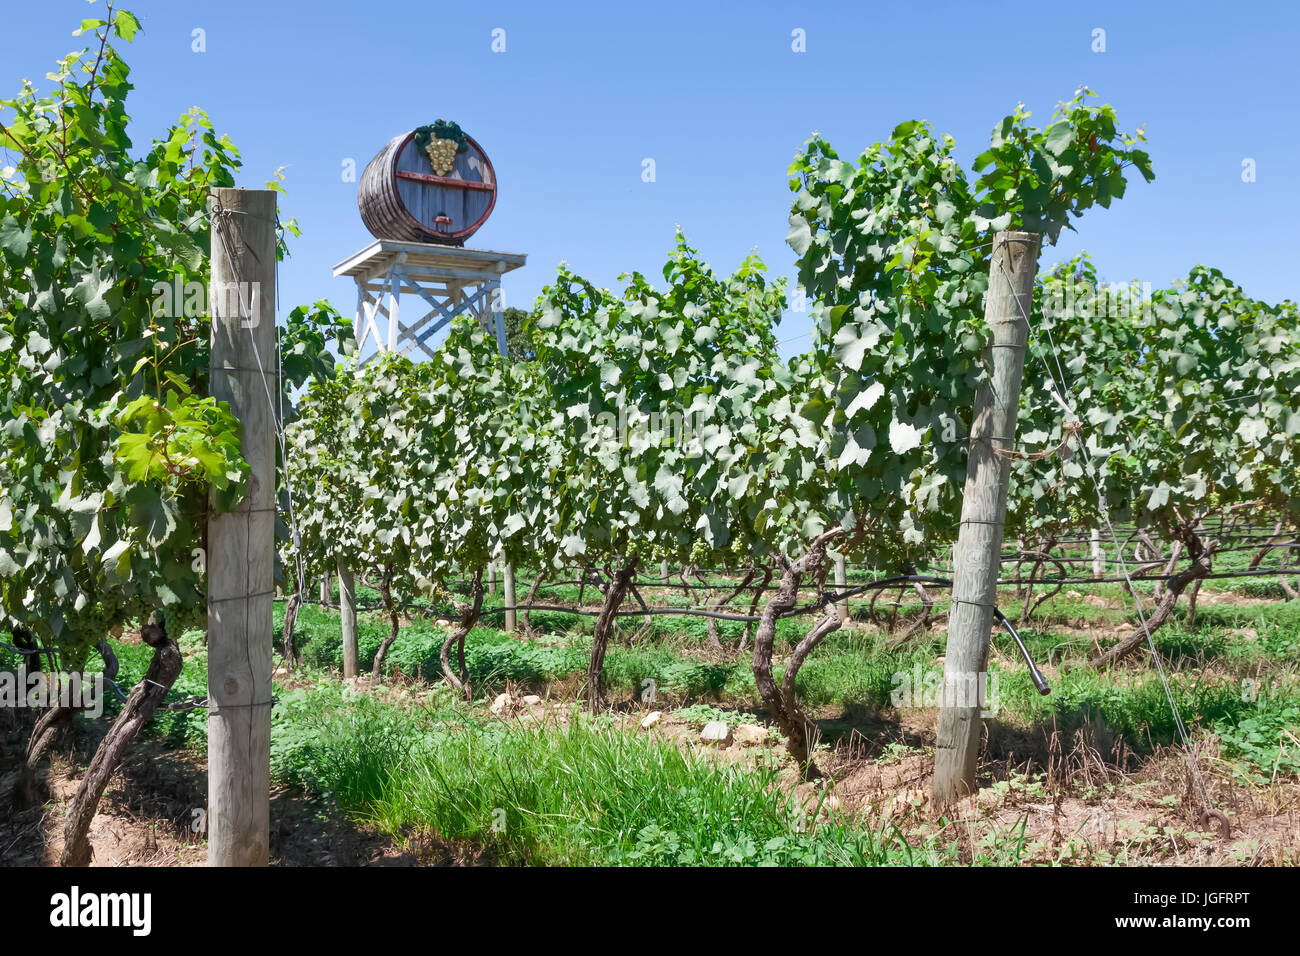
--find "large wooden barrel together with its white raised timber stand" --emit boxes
[334,120,527,358]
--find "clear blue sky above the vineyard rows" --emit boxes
[0,0,1300,354]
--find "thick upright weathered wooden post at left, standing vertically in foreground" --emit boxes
[208,189,280,866]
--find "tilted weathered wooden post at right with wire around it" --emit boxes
[933,232,1041,808]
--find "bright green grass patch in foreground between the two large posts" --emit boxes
[272,684,954,866]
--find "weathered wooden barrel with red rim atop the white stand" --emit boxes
[356,130,497,246]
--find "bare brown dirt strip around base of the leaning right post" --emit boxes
[611,708,1300,866]
